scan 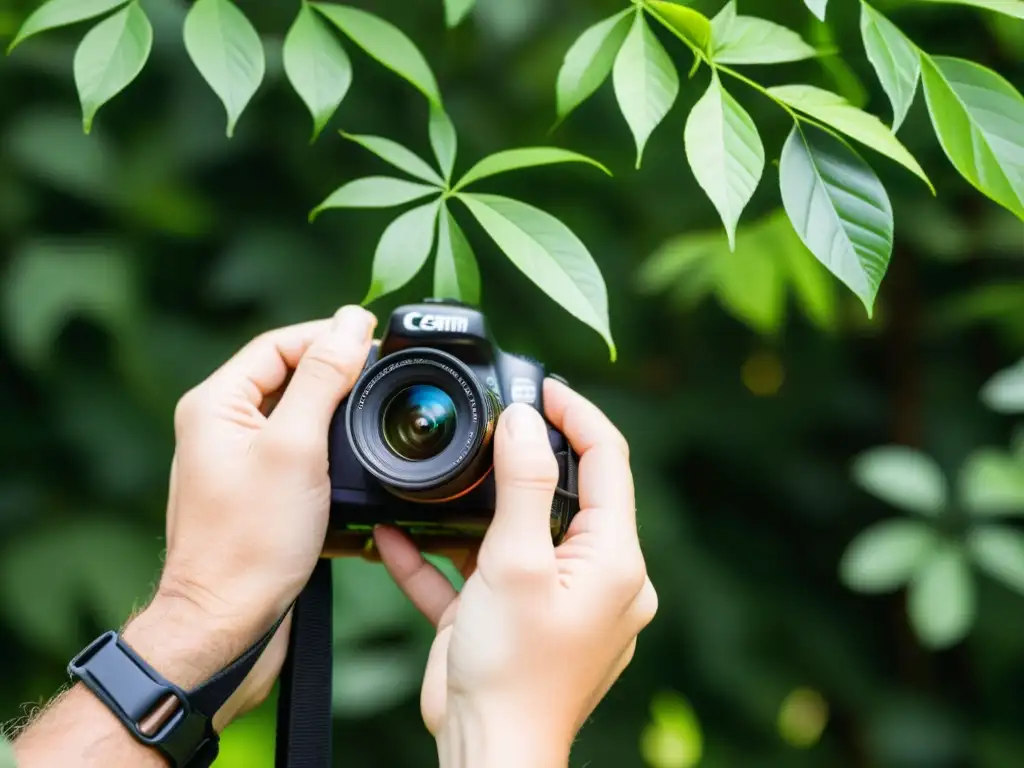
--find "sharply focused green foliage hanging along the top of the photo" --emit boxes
[10,0,1024,335]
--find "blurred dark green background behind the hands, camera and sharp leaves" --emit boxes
[0,0,1024,768]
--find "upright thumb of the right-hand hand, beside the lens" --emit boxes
[479,403,558,579]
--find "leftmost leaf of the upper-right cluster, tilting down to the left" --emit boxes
[555,8,633,120]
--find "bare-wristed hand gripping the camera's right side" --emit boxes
[376,380,657,768]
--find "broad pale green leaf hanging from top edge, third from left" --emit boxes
[184,0,266,137]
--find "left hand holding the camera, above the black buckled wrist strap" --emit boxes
[143,306,376,727]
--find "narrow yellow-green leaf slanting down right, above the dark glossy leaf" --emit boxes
[768,85,935,194]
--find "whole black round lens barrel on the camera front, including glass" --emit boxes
[345,347,502,502]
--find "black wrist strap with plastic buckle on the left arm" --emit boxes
[68,616,284,768]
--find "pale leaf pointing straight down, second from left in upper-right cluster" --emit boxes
[611,11,679,168]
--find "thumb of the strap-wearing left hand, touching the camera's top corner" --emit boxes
[270,305,377,437]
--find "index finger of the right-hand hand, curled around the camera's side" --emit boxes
[544,379,636,541]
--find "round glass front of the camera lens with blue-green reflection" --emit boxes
[381,384,457,462]
